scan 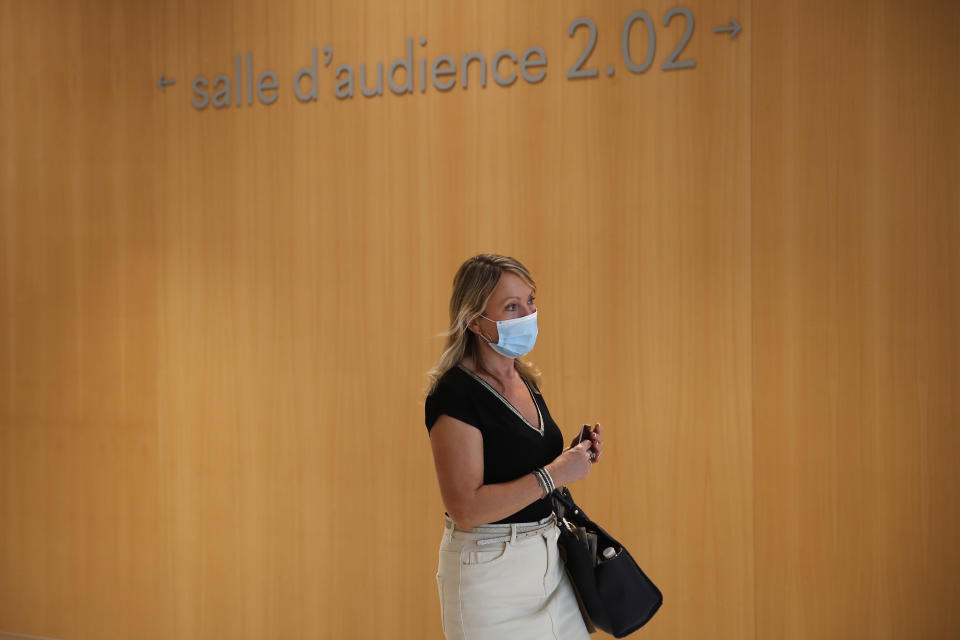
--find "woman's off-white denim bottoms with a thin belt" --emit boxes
[437,515,590,640]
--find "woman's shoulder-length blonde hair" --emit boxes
[427,253,540,394]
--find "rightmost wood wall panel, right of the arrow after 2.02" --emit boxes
[752,2,960,639]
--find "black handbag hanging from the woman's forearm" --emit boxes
[551,487,663,638]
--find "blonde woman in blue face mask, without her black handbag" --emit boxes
[425,254,602,640]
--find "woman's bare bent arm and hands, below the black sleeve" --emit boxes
[430,415,590,529]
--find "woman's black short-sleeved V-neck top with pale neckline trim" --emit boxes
[424,365,563,524]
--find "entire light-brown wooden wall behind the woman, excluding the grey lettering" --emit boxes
[0,0,960,640]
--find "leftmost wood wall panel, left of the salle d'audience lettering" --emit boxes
[0,2,166,638]
